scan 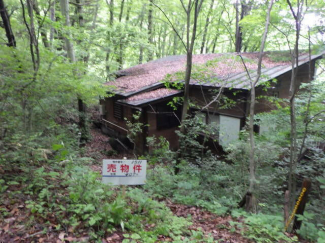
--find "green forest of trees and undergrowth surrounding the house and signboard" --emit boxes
[0,0,325,243]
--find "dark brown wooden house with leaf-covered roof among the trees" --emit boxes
[100,52,325,152]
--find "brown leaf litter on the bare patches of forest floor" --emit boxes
[0,126,304,243]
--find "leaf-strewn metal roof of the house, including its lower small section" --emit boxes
[107,51,325,105]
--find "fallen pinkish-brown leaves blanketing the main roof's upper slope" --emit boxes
[107,53,288,96]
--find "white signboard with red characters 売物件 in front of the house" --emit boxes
[102,159,147,185]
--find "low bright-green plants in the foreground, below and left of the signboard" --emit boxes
[0,153,196,242]
